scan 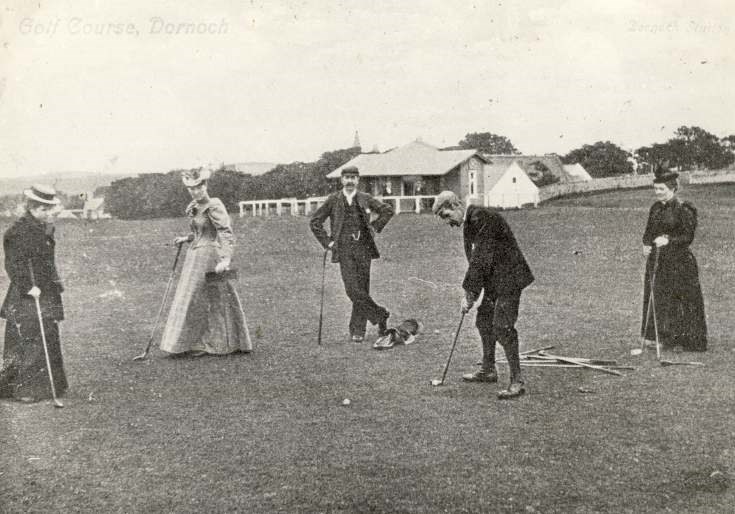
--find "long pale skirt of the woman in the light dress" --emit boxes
[161,246,253,355]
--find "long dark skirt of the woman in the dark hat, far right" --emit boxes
[641,247,707,352]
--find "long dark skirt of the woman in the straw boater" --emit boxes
[0,319,68,400]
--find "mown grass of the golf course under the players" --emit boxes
[0,185,735,513]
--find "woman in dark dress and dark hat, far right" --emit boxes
[641,172,707,352]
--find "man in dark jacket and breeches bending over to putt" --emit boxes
[432,191,533,400]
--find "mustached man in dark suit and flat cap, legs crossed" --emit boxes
[310,166,393,343]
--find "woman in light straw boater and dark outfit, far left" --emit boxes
[0,185,67,402]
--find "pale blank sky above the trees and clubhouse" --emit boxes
[0,0,735,177]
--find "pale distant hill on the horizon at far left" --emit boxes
[0,171,137,196]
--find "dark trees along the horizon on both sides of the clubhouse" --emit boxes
[0,126,735,219]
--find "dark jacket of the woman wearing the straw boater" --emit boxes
[0,212,64,323]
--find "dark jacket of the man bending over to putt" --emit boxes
[462,205,533,298]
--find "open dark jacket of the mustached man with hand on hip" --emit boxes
[309,191,393,262]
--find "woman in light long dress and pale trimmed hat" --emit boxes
[161,167,253,356]
